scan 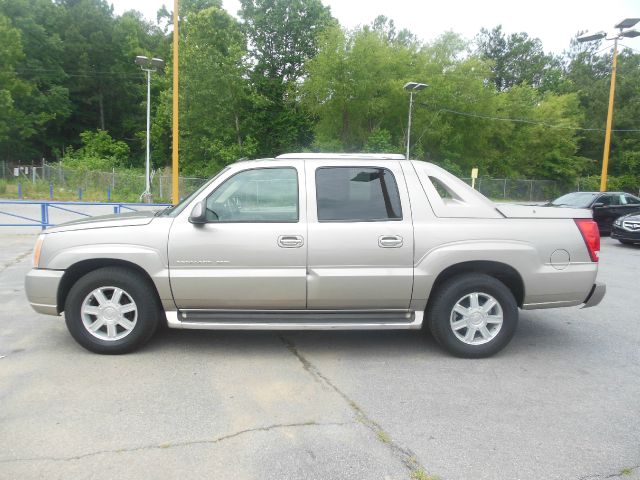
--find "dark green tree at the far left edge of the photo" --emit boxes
[0,0,71,161]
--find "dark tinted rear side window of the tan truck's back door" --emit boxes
[316,167,402,222]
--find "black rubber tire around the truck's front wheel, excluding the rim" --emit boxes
[64,267,161,354]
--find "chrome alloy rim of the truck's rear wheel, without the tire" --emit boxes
[449,292,503,345]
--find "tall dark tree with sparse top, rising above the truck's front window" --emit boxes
[239,0,335,155]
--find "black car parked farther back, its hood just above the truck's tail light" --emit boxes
[548,192,640,234]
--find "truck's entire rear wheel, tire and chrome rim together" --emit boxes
[427,273,518,358]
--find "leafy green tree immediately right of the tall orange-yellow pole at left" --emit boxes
[174,6,255,174]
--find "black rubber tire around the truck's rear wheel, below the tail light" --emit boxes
[426,273,518,358]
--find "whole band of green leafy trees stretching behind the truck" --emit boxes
[0,0,640,191]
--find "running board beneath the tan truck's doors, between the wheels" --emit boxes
[165,310,424,330]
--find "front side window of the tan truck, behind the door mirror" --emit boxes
[206,168,298,223]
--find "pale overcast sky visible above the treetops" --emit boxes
[108,0,640,54]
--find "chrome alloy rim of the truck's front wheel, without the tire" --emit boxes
[80,287,138,342]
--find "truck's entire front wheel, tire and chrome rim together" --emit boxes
[64,267,159,354]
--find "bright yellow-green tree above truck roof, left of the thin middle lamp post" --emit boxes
[302,27,414,151]
